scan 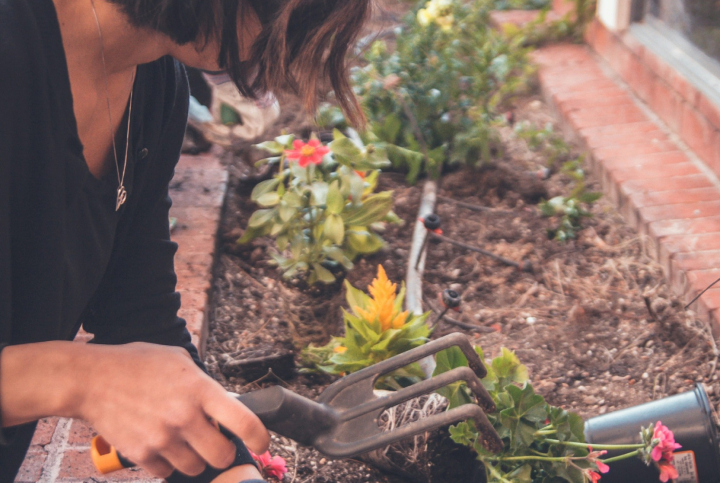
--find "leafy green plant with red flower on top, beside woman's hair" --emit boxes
[238,131,400,285]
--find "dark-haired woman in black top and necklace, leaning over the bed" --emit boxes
[0,0,370,482]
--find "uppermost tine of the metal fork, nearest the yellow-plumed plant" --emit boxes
[318,332,487,403]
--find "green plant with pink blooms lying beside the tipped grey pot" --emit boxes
[433,347,680,483]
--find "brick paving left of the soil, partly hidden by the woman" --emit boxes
[15,152,227,483]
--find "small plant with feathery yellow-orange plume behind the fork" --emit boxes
[303,265,430,389]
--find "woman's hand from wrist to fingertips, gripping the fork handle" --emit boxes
[79,343,269,477]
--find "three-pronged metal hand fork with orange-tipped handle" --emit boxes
[92,333,503,473]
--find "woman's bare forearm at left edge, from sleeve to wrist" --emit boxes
[0,341,90,427]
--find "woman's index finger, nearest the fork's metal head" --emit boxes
[203,387,270,454]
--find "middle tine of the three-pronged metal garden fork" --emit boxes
[340,367,495,421]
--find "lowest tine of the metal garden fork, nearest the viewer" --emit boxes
[317,404,503,458]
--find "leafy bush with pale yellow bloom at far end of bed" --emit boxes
[352,0,532,183]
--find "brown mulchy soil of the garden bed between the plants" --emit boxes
[201,91,720,483]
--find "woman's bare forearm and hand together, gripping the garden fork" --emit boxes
[0,342,270,478]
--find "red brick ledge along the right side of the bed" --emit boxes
[533,45,720,331]
